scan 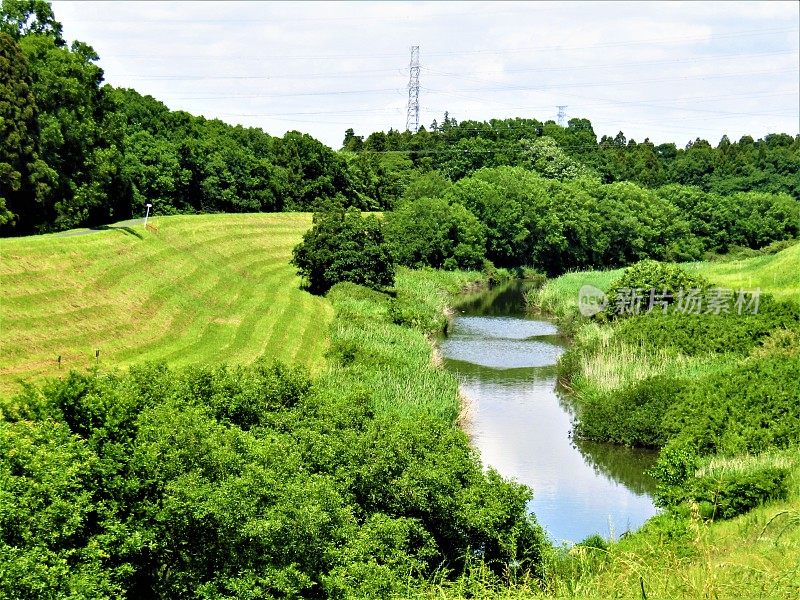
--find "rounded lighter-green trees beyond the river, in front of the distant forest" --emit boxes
[386,166,800,275]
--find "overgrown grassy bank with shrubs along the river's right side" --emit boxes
[500,246,800,600]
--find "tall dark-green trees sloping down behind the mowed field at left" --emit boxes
[0,0,368,235]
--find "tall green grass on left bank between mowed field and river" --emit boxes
[328,269,484,424]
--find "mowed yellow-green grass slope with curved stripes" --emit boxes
[0,213,333,393]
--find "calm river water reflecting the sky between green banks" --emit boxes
[440,282,656,543]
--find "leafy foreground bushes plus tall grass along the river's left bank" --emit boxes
[0,272,546,598]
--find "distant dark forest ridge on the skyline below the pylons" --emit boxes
[343,113,800,199]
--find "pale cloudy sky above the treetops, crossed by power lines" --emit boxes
[53,0,800,149]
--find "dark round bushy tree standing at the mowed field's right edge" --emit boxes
[292,208,395,294]
